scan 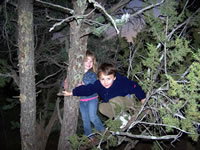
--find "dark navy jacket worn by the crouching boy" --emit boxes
[73,73,146,102]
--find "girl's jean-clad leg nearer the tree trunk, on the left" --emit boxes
[80,101,92,136]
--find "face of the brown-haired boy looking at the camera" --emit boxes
[99,73,116,89]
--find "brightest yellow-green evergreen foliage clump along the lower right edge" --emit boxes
[166,50,200,141]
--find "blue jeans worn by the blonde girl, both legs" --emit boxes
[80,98,105,136]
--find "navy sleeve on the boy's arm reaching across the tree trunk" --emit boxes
[72,84,97,96]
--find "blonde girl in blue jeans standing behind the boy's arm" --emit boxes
[61,51,105,137]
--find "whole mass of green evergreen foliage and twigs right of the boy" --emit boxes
[115,0,200,145]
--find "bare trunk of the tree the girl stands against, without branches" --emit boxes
[58,0,87,150]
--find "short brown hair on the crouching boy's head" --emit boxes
[97,63,117,78]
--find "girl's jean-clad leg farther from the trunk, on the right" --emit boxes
[88,98,105,132]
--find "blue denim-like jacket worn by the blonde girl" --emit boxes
[80,70,98,99]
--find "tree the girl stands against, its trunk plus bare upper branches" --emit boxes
[26,0,166,149]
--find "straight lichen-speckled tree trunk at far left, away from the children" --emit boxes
[18,0,37,150]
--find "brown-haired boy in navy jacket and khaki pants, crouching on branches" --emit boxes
[63,63,146,118]
